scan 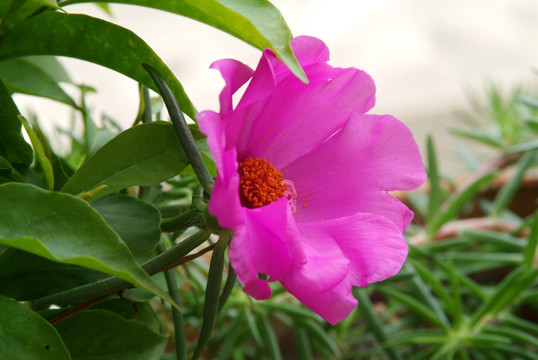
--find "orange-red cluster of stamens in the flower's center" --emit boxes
[239,156,288,209]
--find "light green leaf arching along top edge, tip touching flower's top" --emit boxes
[62,0,306,81]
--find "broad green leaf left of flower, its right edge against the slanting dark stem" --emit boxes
[62,122,187,197]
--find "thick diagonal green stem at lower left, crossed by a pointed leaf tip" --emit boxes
[34,230,211,306]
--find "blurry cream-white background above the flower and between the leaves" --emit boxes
[12,0,538,174]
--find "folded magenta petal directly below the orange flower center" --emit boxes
[229,198,305,299]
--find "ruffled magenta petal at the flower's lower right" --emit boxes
[280,213,407,324]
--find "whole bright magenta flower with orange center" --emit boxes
[198,37,425,324]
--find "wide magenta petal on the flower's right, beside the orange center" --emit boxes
[283,114,425,231]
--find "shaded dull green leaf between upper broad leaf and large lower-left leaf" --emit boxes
[92,195,161,263]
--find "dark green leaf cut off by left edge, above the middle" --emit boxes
[0,80,33,167]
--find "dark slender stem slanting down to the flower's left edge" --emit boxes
[142,64,214,194]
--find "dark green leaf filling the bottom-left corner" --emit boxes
[0,296,71,360]
